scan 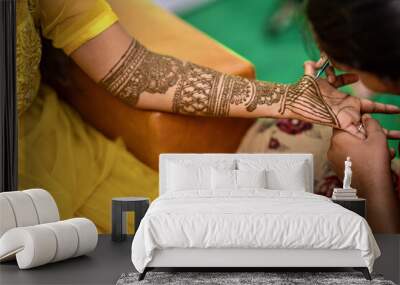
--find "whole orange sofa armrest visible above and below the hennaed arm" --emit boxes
[46,0,254,169]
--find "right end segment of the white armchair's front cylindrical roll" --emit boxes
[64,218,98,257]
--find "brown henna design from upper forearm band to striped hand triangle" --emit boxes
[100,41,339,126]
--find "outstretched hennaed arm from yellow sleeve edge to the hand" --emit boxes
[71,23,398,132]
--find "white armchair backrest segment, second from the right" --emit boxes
[1,191,39,227]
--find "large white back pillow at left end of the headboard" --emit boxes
[167,163,211,191]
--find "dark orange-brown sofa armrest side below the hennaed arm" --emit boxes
[58,63,254,170]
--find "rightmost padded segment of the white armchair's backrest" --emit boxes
[23,189,60,224]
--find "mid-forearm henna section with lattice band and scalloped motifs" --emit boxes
[173,66,286,116]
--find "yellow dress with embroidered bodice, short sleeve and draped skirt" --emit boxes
[17,0,158,232]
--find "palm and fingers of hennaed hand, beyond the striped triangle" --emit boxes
[304,61,400,139]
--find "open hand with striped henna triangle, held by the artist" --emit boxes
[296,61,400,139]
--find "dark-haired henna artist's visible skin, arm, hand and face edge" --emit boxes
[310,58,400,233]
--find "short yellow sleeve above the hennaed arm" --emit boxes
[39,0,118,55]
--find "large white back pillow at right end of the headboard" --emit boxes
[238,159,310,191]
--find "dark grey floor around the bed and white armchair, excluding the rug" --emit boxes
[0,235,400,285]
